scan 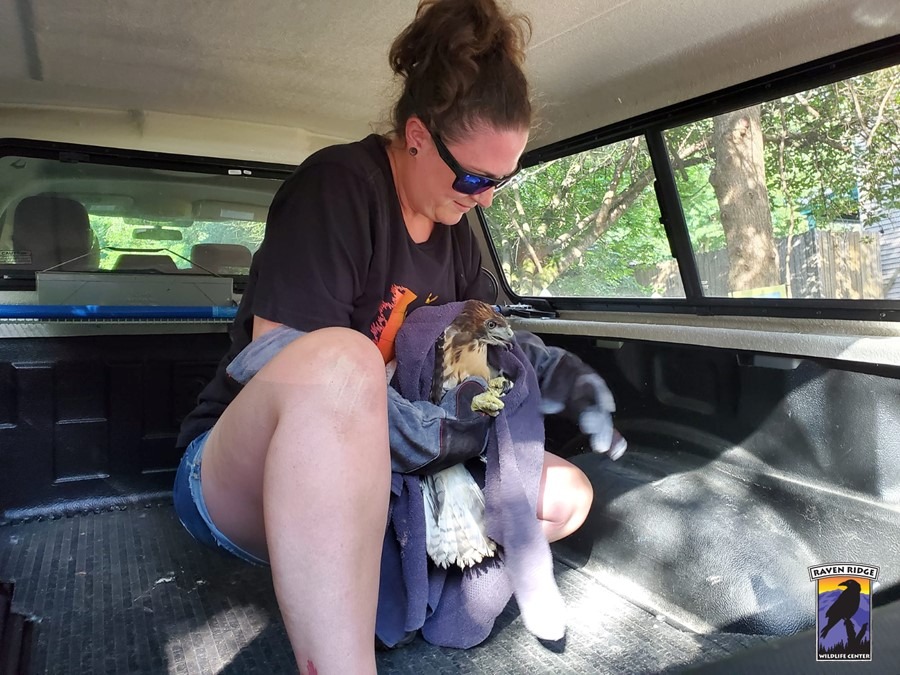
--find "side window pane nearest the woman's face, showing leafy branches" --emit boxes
[485,137,681,298]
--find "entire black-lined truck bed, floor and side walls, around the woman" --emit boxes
[0,335,900,675]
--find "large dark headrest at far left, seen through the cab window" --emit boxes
[12,195,99,270]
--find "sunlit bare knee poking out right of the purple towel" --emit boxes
[537,452,594,542]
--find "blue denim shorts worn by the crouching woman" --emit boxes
[173,429,269,566]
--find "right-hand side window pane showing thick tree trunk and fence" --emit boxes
[665,66,900,299]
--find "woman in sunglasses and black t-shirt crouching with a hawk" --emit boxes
[175,0,616,674]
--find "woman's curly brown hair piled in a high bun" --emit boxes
[388,0,532,141]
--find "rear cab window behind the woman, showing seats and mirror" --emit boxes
[0,155,281,279]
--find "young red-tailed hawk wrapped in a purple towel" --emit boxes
[422,300,513,569]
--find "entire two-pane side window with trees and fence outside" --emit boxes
[485,60,900,300]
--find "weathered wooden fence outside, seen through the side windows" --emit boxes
[635,230,884,300]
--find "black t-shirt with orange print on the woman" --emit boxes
[178,134,487,447]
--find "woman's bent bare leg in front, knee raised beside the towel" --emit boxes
[201,328,390,675]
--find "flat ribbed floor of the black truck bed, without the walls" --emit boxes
[0,503,765,675]
